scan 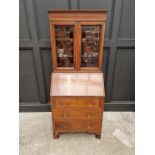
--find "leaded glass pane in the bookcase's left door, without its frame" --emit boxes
[55,25,74,67]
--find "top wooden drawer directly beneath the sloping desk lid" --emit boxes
[53,97,100,108]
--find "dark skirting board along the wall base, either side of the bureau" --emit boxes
[19,101,135,112]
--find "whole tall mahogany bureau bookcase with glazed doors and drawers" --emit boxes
[48,10,107,138]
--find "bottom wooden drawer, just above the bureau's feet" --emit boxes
[55,120,101,131]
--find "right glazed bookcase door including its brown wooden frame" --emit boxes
[78,22,105,72]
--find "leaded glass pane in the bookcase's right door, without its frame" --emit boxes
[81,25,101,67]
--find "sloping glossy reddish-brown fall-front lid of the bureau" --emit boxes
[50,73,105,96]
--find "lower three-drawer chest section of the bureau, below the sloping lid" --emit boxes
[51,97,104,132]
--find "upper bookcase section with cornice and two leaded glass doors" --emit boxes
[49,10,106,72]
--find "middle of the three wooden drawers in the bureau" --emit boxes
[53,108,102,119]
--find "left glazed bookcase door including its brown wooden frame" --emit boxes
[50,22,77,72]
